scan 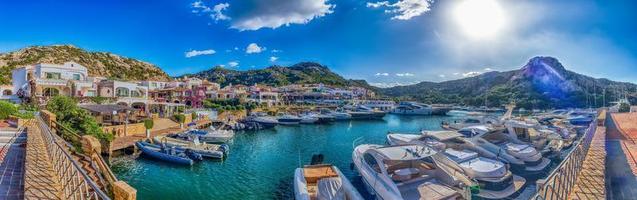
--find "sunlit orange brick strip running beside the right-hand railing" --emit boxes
[569,127,606,199]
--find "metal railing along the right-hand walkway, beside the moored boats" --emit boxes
[531,120,597,200]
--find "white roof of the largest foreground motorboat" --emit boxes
[373,145,438,161]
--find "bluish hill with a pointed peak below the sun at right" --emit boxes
[380,57,637,108]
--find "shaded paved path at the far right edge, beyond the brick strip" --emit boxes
[606,117,637,199]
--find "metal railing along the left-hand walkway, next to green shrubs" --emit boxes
[36,115,110,200]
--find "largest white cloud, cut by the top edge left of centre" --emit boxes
[230,0,335,31]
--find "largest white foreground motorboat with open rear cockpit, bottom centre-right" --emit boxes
[352,144,471,200]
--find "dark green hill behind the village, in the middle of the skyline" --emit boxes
[182,62,377,89]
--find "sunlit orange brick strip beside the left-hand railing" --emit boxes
[24,121,62,199]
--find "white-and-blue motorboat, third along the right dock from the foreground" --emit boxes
[458,125,551,172]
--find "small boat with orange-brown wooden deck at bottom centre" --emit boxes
[294,164,363,200]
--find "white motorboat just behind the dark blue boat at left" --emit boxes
[153,135,230,159]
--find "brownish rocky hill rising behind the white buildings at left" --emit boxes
[0,45,170,84]
